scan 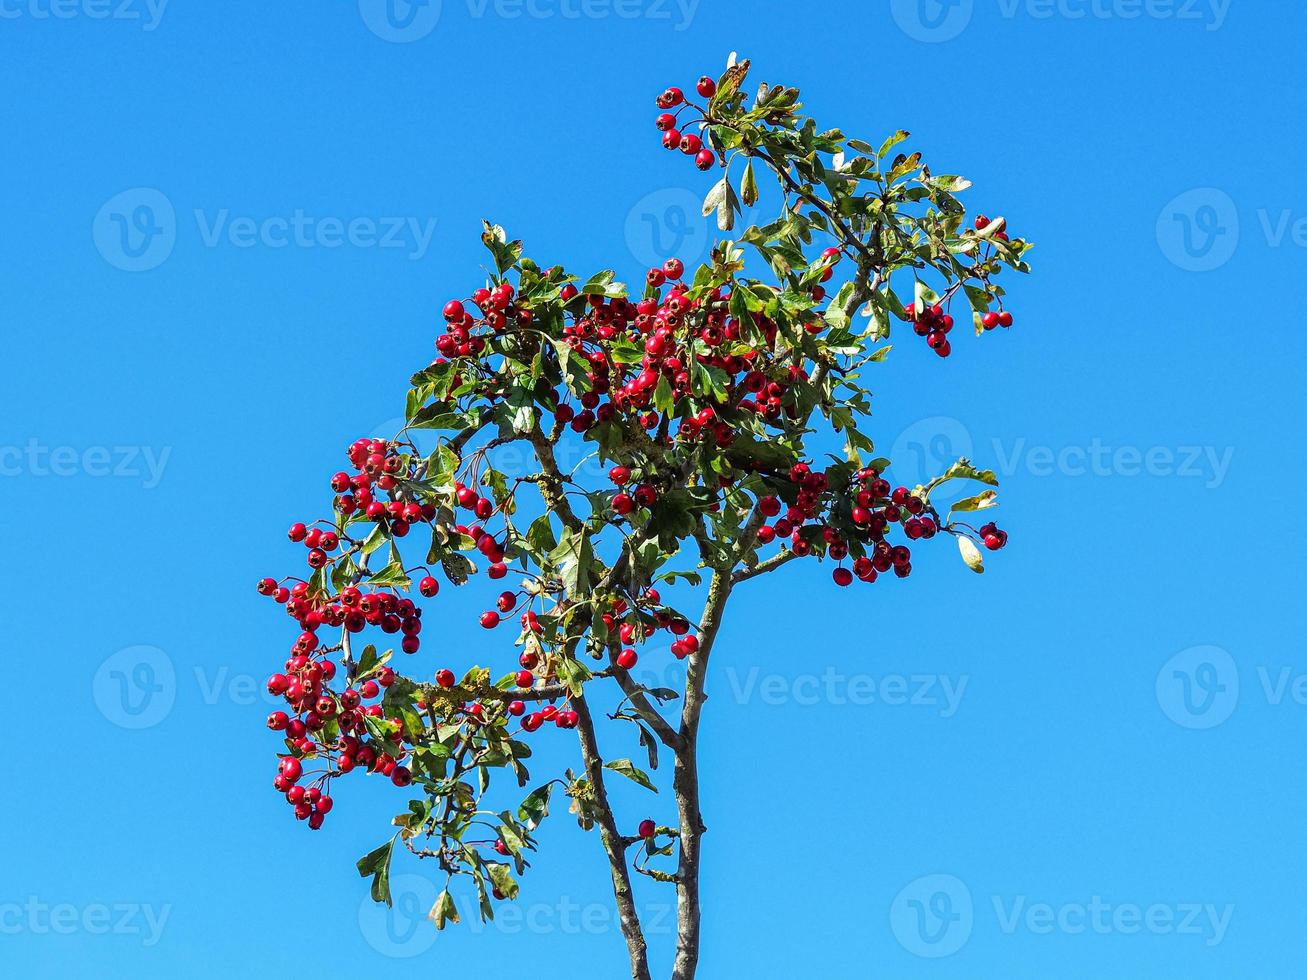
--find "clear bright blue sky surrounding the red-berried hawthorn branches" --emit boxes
[0,0,1307,980]
